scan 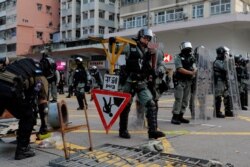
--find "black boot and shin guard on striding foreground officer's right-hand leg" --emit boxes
[146,100,165,139]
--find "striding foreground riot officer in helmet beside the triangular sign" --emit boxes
[118,28,165,139]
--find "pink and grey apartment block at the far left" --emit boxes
[0,0,60,56]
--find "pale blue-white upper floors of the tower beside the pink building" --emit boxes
[60,0,119,41]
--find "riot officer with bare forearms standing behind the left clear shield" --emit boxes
[171,41,197,125]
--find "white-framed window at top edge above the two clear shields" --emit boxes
[211,0,231,15]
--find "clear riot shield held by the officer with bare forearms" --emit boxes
[190,46,213,120]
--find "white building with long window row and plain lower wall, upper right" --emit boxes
[105,0,250,59]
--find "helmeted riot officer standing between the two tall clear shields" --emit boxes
[213,46,234,118]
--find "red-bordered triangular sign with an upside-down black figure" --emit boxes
[91,89,131,133]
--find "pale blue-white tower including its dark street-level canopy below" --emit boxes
[56,0,119,72]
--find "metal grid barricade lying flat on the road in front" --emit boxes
[49,144,232,167]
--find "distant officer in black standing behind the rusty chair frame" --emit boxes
[73,57,88,110]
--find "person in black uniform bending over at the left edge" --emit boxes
[0,58,46,160]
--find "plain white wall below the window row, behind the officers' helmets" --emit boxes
[156,27,250,55]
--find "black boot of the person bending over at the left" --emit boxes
[15,145,35,160]
